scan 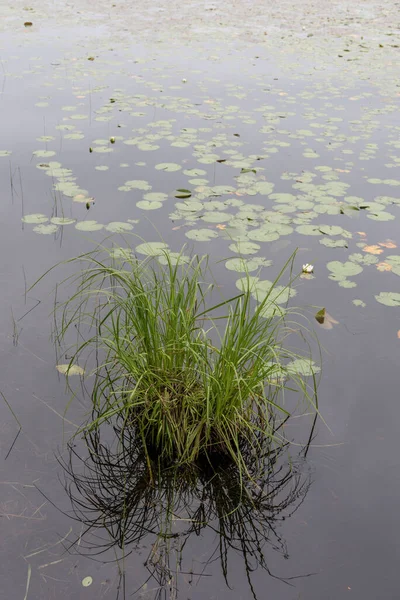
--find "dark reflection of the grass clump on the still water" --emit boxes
[62,424,310,598]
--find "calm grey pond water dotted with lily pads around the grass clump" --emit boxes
[0,0,400,600]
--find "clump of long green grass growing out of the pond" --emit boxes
[52,248,315,471]
